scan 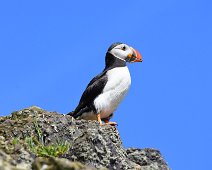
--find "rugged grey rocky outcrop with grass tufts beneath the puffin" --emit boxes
[0,106,169,170]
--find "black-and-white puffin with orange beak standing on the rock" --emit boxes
[68,42,142,126]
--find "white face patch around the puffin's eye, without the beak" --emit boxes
[109,44,132,61]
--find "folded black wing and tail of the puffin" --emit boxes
[68,71,108,118]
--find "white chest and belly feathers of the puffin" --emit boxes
[94,67,131,118]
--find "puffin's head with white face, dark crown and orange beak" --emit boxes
[108,42,142,63]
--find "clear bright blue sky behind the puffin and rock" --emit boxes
[0,0,212,170]
